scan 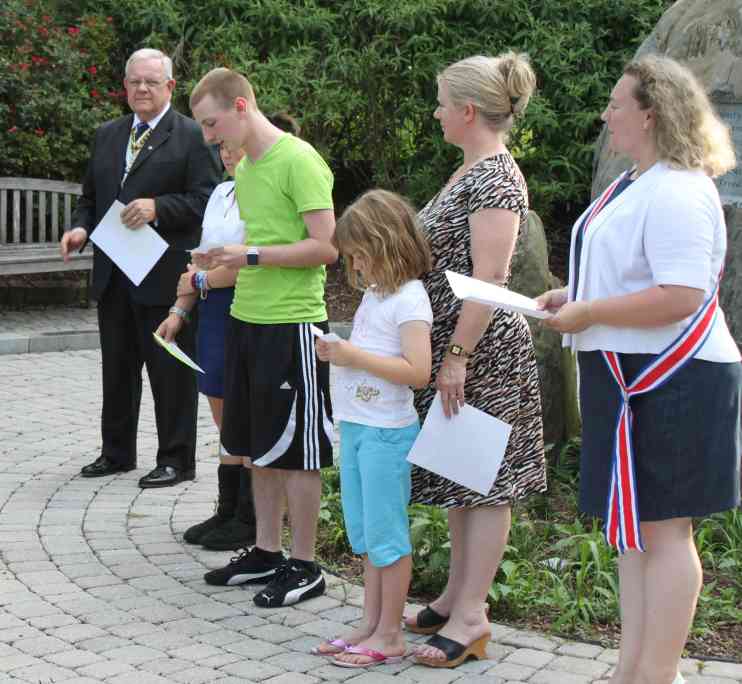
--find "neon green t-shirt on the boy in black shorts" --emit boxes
[231,133,333,323]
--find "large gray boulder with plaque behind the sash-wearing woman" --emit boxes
[592,0,742,345]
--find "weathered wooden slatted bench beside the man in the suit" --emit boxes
[0,178,93,283]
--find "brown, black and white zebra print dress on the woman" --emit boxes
[412,154,546,508]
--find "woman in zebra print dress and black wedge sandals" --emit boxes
[405,53,546,667]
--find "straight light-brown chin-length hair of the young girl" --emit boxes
[334,189,432,296]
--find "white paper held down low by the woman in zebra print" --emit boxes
[407,392,511,495]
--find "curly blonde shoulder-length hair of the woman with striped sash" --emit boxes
[624,55,736,176]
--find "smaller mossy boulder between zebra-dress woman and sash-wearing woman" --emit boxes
[509,211,579,444]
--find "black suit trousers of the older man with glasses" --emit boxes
[98,266,198,470]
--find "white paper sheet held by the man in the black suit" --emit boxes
[90,200,167,285]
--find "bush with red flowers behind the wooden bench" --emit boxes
[0,0,125,180]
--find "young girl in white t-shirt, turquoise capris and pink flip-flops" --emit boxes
[314,190,433,667]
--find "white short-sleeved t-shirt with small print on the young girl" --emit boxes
[333,280,433,428]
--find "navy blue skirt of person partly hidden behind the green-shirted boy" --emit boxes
[197,287,234,399]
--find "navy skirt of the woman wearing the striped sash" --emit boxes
[578,351,742,521]
